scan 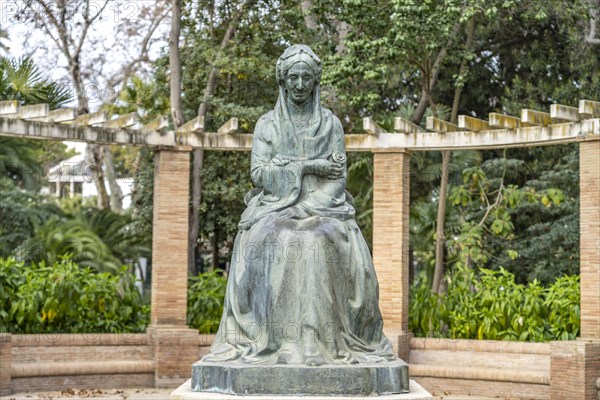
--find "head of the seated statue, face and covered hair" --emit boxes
[277,44,321,104]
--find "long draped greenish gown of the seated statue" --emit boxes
[203,103,395,365]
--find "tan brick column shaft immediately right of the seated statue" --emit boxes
[373,149,410,340]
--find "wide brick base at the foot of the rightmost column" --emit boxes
[550,340,600,400]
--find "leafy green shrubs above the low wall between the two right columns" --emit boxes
[409,267,580,342]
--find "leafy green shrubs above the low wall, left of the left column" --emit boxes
[0,258,150,333]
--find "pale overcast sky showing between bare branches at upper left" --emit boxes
[0,0,170,153]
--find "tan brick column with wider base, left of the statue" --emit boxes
[148,149,200,387]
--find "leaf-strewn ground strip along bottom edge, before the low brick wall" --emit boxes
[0,388,519,400]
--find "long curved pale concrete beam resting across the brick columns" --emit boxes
[0,116,600,151]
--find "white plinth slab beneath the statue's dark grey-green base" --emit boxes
[171,379,433,400]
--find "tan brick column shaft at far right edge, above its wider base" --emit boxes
[579,138,600,341]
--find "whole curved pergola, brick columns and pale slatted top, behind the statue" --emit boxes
[0,100,600,400]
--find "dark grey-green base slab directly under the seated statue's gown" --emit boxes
[192,360,409,396]
